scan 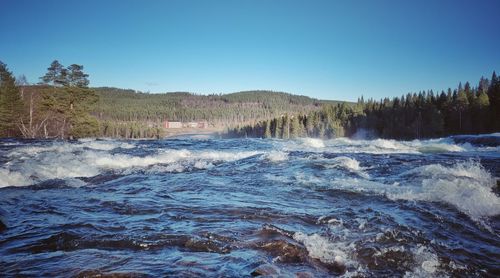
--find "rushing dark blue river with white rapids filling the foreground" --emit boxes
[0,134,500,277]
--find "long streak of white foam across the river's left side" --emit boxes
[0,140,262,186]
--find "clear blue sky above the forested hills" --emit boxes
[0,0,500,100]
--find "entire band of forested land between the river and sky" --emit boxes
[0,60,500,140]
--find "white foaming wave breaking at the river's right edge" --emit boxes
[319,161,500,228]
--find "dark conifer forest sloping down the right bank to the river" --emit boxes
[228,72,500,139]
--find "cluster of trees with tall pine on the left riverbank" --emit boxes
[0,60,99,139]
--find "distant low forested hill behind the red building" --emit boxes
[91,87,348,126]
